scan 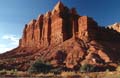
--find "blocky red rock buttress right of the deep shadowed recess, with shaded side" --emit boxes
[78,16,98,41]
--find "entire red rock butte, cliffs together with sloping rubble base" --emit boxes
[0,2,120,70]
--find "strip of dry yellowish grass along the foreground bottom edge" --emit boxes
[0,70,120,78]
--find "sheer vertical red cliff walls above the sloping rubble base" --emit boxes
[20,2,97,48]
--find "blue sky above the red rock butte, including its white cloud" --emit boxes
[0,0,120,53]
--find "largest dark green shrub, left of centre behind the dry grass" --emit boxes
[28,60,52,73]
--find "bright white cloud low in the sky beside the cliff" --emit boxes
[0,34,19,53]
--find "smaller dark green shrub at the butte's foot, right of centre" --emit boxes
[80,64,95,72]
